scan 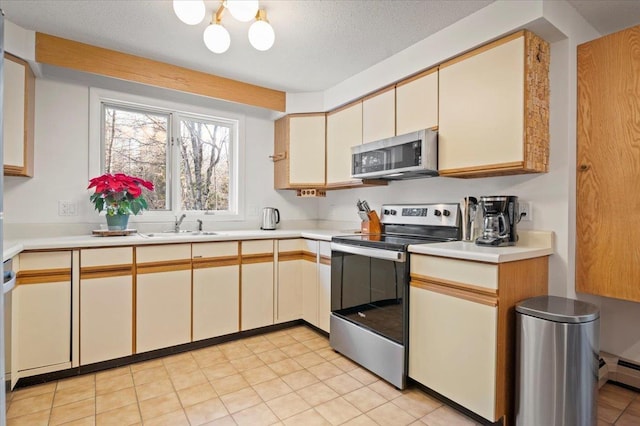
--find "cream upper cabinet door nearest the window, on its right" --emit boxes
[289,114,326,186]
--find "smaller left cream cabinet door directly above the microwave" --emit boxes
[362,87,396,143]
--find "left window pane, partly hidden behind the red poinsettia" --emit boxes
[103,105,169,210]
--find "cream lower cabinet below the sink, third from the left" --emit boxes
[136,244,191,353]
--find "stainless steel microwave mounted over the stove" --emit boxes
[351,129,438,180]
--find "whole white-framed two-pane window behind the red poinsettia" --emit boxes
[90,88,245,217]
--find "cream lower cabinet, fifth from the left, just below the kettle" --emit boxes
[240,240,274,331]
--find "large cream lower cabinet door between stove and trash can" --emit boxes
[409,284,498,421]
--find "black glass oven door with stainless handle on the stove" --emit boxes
[331,243,408,345]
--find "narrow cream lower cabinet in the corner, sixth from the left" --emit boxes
[275,238,305,323]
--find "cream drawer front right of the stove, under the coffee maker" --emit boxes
[411,255,498,290]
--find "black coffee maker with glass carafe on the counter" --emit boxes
[476,195,520,247]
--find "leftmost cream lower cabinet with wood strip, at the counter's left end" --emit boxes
[11,251,71,376]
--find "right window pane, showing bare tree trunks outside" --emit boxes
[180,118,231,211]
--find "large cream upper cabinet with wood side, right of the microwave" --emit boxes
[438,31,550,177]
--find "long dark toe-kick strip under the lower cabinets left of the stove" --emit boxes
[14,320,304,389]
